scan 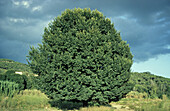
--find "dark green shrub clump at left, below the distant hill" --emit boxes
[0,70,31,90]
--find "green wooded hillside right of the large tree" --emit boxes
[131,72,170,98]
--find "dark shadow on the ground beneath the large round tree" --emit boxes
[49,100,83,110]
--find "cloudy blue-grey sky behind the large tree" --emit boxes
[0,0,170,78]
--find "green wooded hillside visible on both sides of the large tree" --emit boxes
[0,59,170,98]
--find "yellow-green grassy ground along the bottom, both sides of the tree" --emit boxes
[0,90,170,111]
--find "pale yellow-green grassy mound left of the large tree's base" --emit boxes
[0,90,50,110]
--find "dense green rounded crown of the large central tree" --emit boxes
[28,9,133,105]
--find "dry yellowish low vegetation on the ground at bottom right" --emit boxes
[111,94,170,111]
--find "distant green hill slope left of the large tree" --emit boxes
[0,59,31,73]
